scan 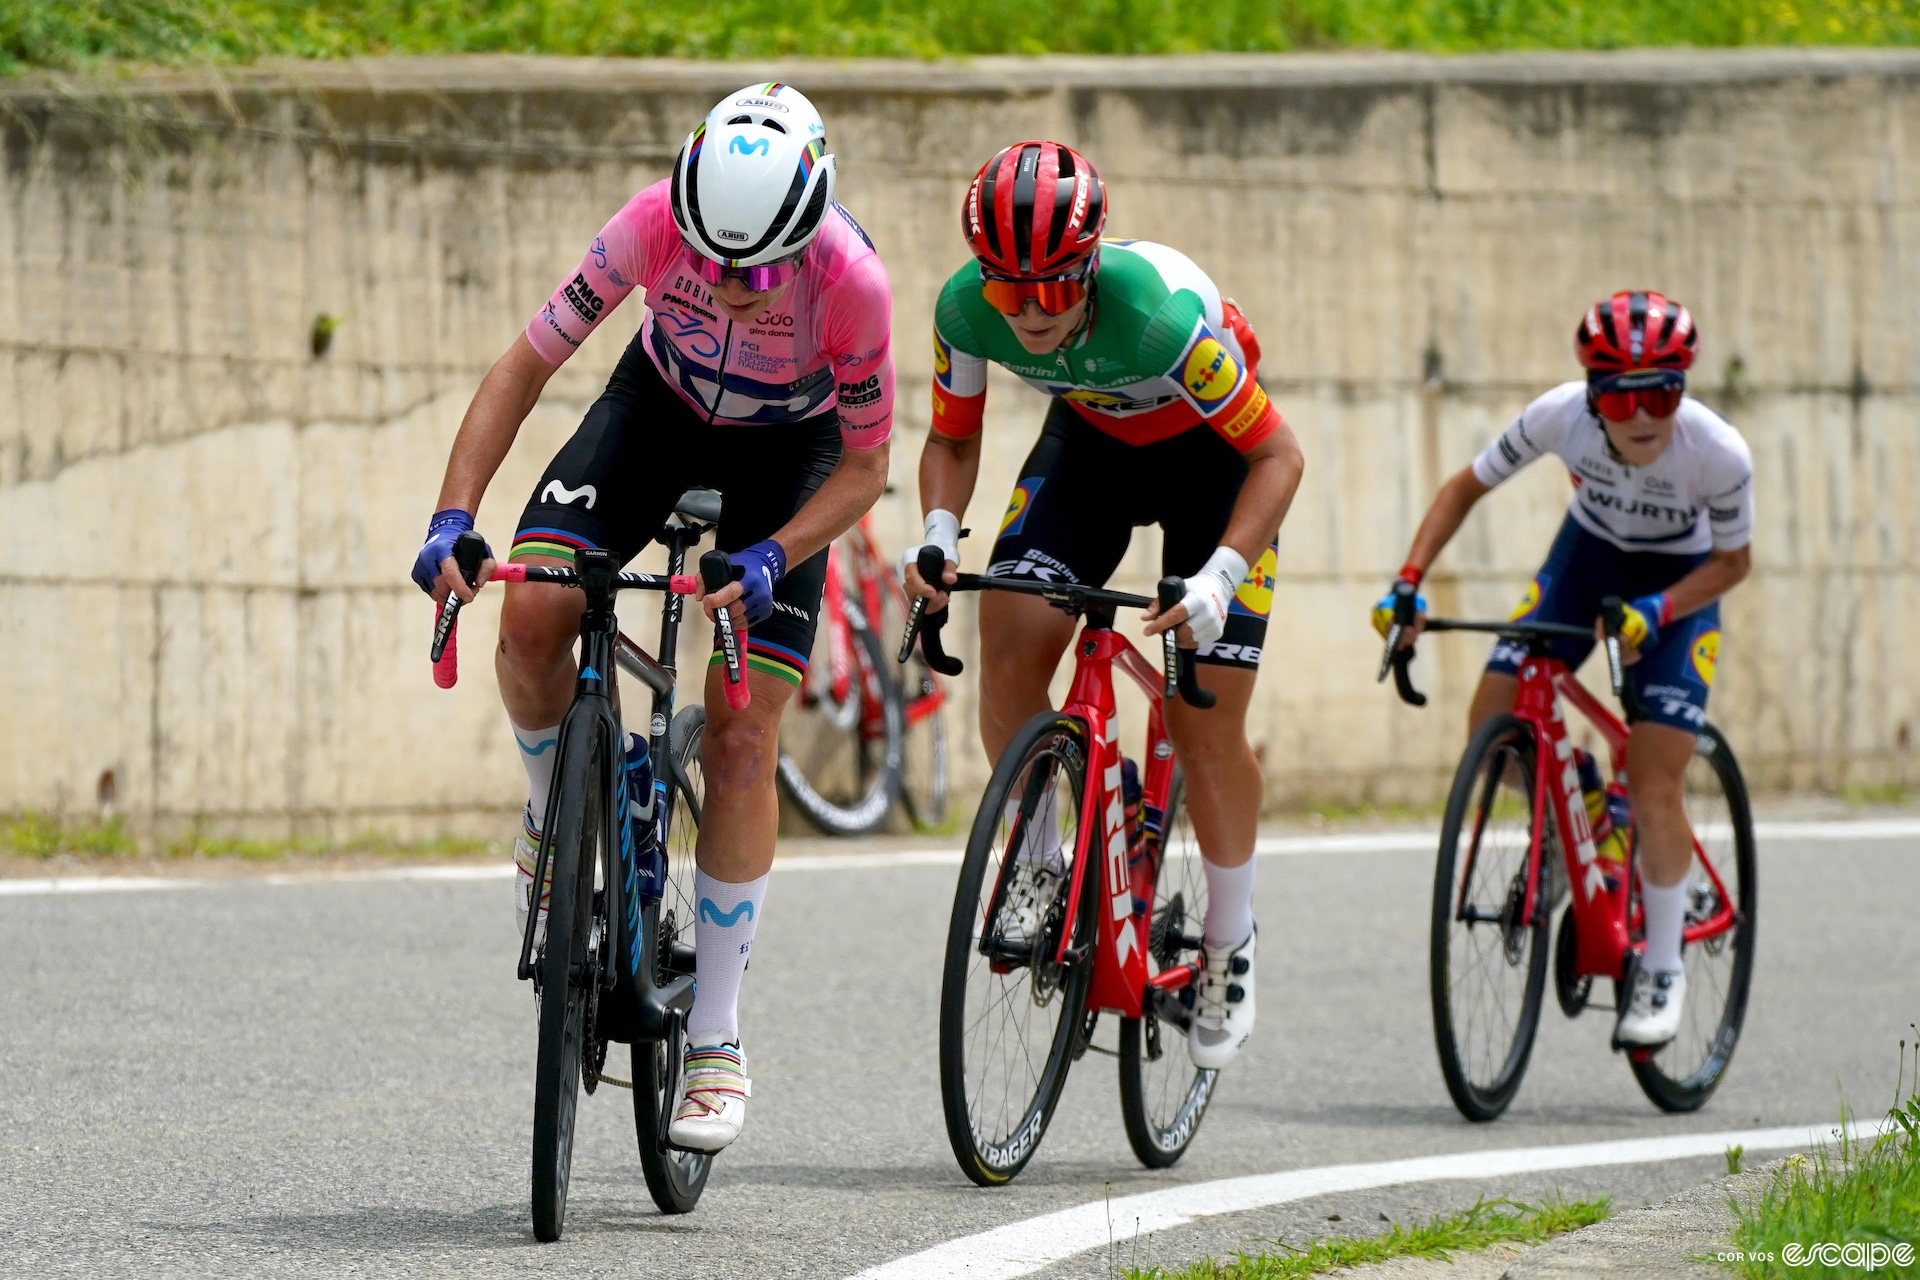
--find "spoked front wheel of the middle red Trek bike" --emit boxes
[941,712,1098,1186]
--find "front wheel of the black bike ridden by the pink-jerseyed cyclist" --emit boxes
[532,716,607,1242]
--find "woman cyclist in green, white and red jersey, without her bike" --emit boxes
[904,140,1304,1067]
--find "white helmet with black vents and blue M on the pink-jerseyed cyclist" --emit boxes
[672,81,833,267]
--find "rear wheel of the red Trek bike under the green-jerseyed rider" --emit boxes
[1119,768,1219,1169]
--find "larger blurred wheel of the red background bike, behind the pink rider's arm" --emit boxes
[780,601,904,835]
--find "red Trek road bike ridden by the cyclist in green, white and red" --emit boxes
[902,549,1217,1186]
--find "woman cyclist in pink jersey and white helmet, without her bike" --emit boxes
[413,83,893,1151]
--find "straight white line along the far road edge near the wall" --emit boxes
[0,818,1920,898]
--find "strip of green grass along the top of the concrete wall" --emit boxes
[0,0,1920,71]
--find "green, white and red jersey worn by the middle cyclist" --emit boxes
[933,240,1281,451]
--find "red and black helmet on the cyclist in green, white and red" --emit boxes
[960,140,1106,280]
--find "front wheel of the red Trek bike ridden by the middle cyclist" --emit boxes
[941,712,1100,1186]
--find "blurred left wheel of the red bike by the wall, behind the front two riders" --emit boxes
[780,614,906,835]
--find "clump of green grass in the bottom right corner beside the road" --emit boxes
[1734,1042,1920,1280]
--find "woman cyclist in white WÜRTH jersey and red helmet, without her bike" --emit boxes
[1373,292,1753,1046]
